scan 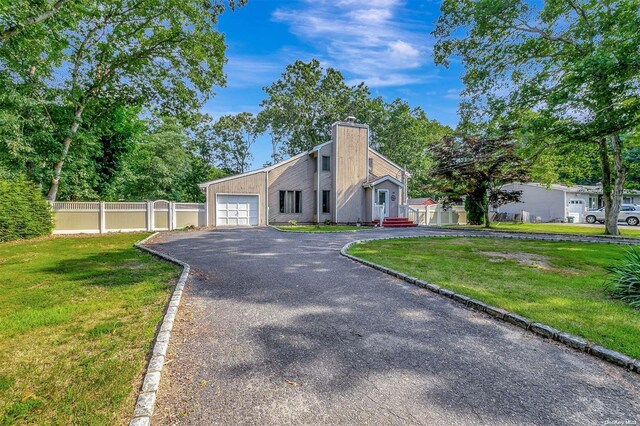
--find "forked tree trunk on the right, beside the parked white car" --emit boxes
[598,135,625,235]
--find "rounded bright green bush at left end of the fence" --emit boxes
[0,179,53,241]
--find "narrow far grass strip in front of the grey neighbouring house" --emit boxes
[446,222,640,238]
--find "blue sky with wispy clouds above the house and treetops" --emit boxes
[208,0,462,168]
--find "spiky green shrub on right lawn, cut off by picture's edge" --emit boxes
[605,247,640,309]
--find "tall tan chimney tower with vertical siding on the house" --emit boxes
[331,123,369,223]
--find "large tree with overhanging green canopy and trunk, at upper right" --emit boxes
[434,0,640,234]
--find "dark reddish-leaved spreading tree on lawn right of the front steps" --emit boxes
[429,134,527,227]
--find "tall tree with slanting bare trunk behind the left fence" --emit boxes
[0,0,244,201]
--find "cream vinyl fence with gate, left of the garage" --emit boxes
[53,200,207,234]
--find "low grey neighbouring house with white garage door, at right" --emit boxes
[496,183,640,222]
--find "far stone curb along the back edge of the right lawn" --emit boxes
[430,225,640,245]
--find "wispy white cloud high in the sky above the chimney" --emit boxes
[272,0,429,87]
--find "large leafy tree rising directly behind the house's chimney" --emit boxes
[260,59,369,155]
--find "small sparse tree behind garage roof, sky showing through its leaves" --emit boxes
[214,112,258,173]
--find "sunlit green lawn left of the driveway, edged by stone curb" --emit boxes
[0,234,179,425]
